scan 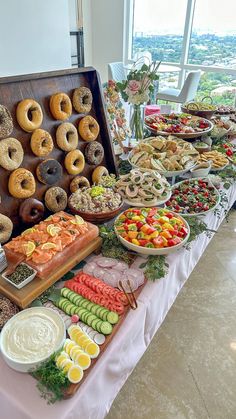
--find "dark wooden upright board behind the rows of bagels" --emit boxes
[0,67,116,230]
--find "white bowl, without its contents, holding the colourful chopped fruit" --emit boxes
[114,211,190,256]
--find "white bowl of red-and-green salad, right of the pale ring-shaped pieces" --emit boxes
[165,178,220,216]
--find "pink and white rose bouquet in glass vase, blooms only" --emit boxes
[117,61,161,105]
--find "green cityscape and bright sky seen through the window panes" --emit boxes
[132,0,236,105]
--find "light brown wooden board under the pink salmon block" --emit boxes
[0,237,102,309]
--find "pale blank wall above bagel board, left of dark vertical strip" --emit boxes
[0,0,71,76]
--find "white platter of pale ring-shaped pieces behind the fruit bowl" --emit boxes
[114,169,171,207]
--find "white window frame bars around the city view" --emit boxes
[123,0,236,89]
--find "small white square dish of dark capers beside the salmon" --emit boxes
[2,263,37,289]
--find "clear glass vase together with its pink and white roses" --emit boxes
[117,61,160,141]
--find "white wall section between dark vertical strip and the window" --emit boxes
[83,0,124,82]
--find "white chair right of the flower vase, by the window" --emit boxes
[156,70,202,103]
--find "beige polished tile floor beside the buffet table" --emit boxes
[106,210,236,419]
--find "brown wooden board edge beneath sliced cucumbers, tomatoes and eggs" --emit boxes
[64,279,147,399]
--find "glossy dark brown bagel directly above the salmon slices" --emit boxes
[19,198,45,224]
